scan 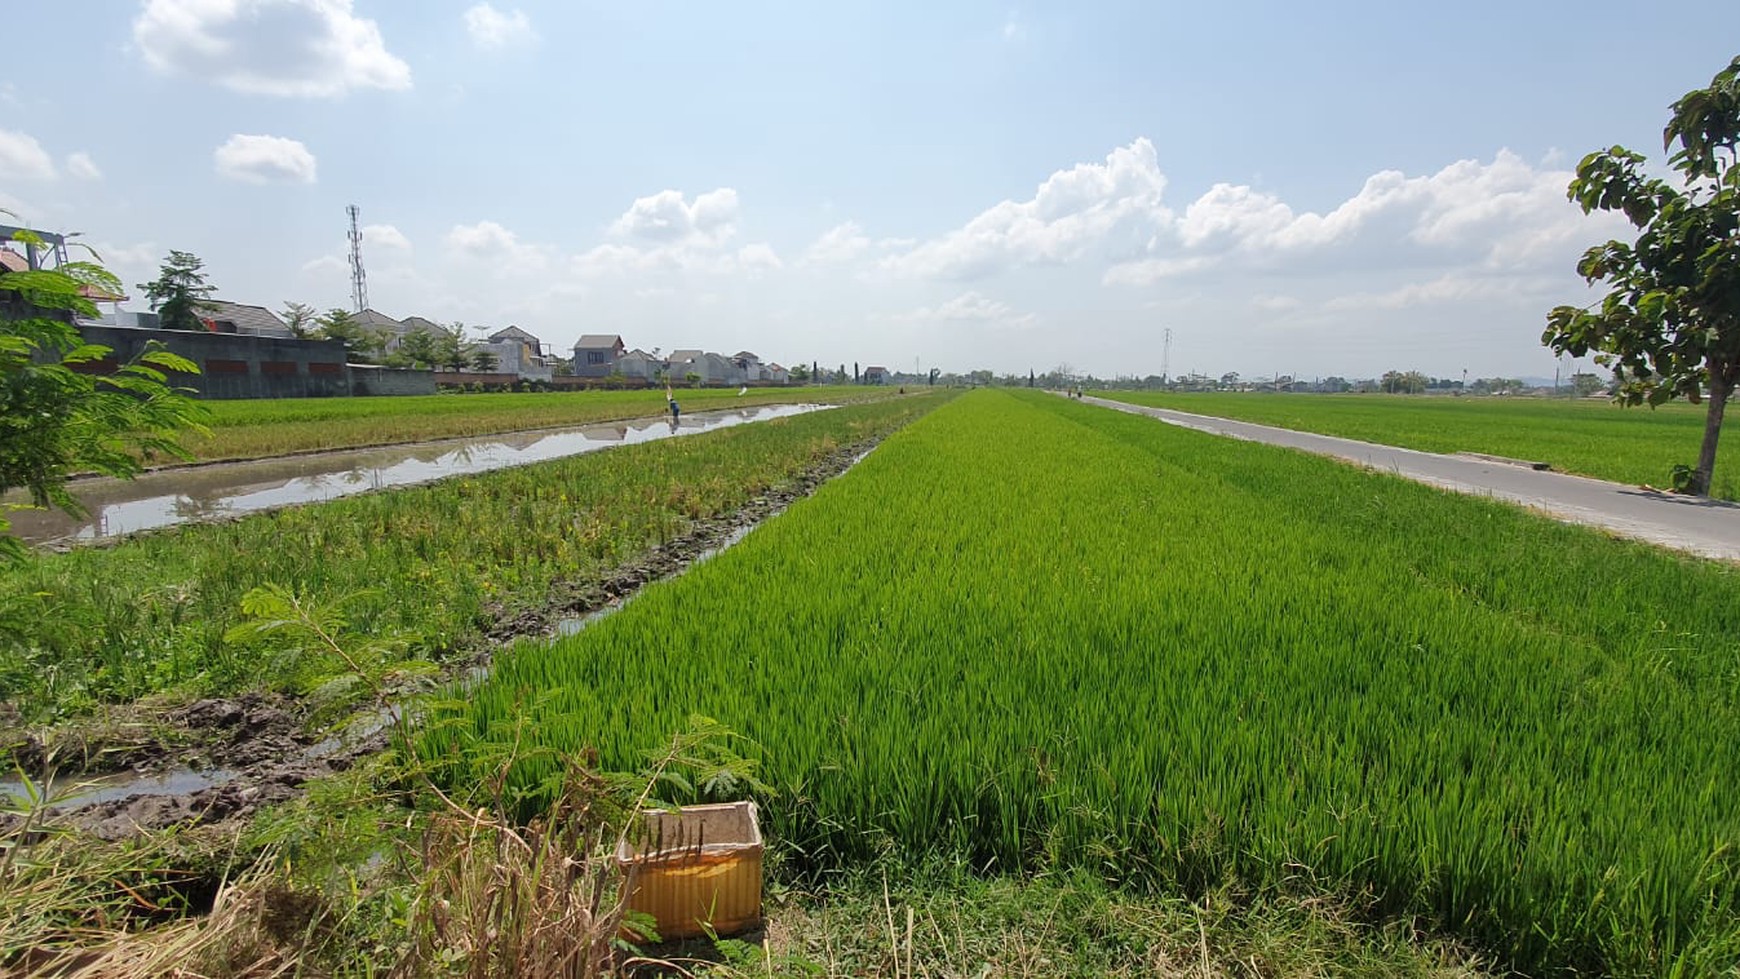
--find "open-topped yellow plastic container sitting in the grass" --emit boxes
[616,802,762,939]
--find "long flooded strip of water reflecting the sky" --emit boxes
[10,405,827,543]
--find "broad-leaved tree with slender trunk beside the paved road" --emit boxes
[1542,57,1740,496]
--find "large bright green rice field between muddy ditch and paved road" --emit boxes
[445,391,1740,976]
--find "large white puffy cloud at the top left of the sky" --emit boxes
[132,0,411,97]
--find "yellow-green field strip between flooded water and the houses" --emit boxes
[188,386,889,461]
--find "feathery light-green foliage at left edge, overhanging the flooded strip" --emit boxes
[0,231,205,560]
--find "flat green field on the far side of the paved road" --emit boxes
[1100,391,1740,499]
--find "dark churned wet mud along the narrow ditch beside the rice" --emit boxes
[0,438,879,840]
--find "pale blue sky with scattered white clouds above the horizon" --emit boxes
[0,0,1740,377]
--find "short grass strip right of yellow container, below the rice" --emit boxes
[702,861,1486,979]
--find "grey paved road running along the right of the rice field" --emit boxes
[1082,398,1740,562]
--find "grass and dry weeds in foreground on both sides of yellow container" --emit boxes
[0,756,1488,979]
